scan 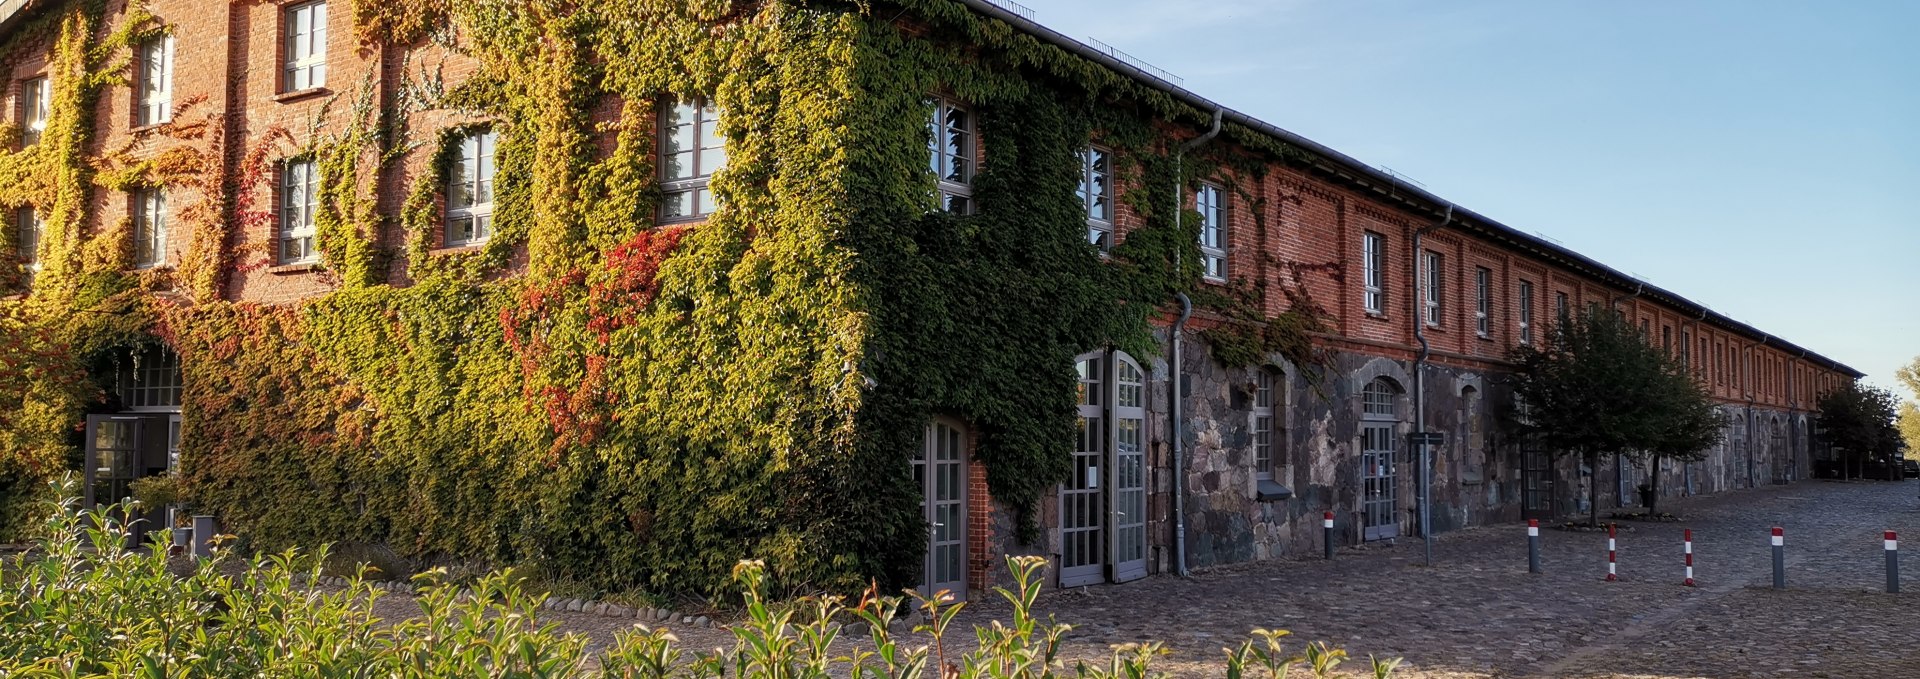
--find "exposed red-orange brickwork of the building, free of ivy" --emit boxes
[0,0,1857,587]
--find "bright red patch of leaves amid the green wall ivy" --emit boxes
[499,228,685,464]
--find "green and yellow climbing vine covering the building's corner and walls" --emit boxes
[0,0,1319,591]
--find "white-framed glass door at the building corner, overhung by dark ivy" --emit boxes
[914,418,968,600]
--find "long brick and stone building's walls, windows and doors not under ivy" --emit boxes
[0,0,1860,589]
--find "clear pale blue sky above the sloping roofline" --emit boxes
[1021,0,1920,395]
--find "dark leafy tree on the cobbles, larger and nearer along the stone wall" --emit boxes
[1511,306,1720,526]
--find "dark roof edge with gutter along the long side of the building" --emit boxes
[956,0,1866,378]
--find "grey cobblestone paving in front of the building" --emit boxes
[360,481,1920,679]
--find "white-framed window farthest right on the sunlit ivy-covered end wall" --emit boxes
[660,100,726,222]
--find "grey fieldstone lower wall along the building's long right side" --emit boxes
[977,338,1811,585]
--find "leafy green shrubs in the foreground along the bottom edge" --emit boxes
[0,503,1398,679]
